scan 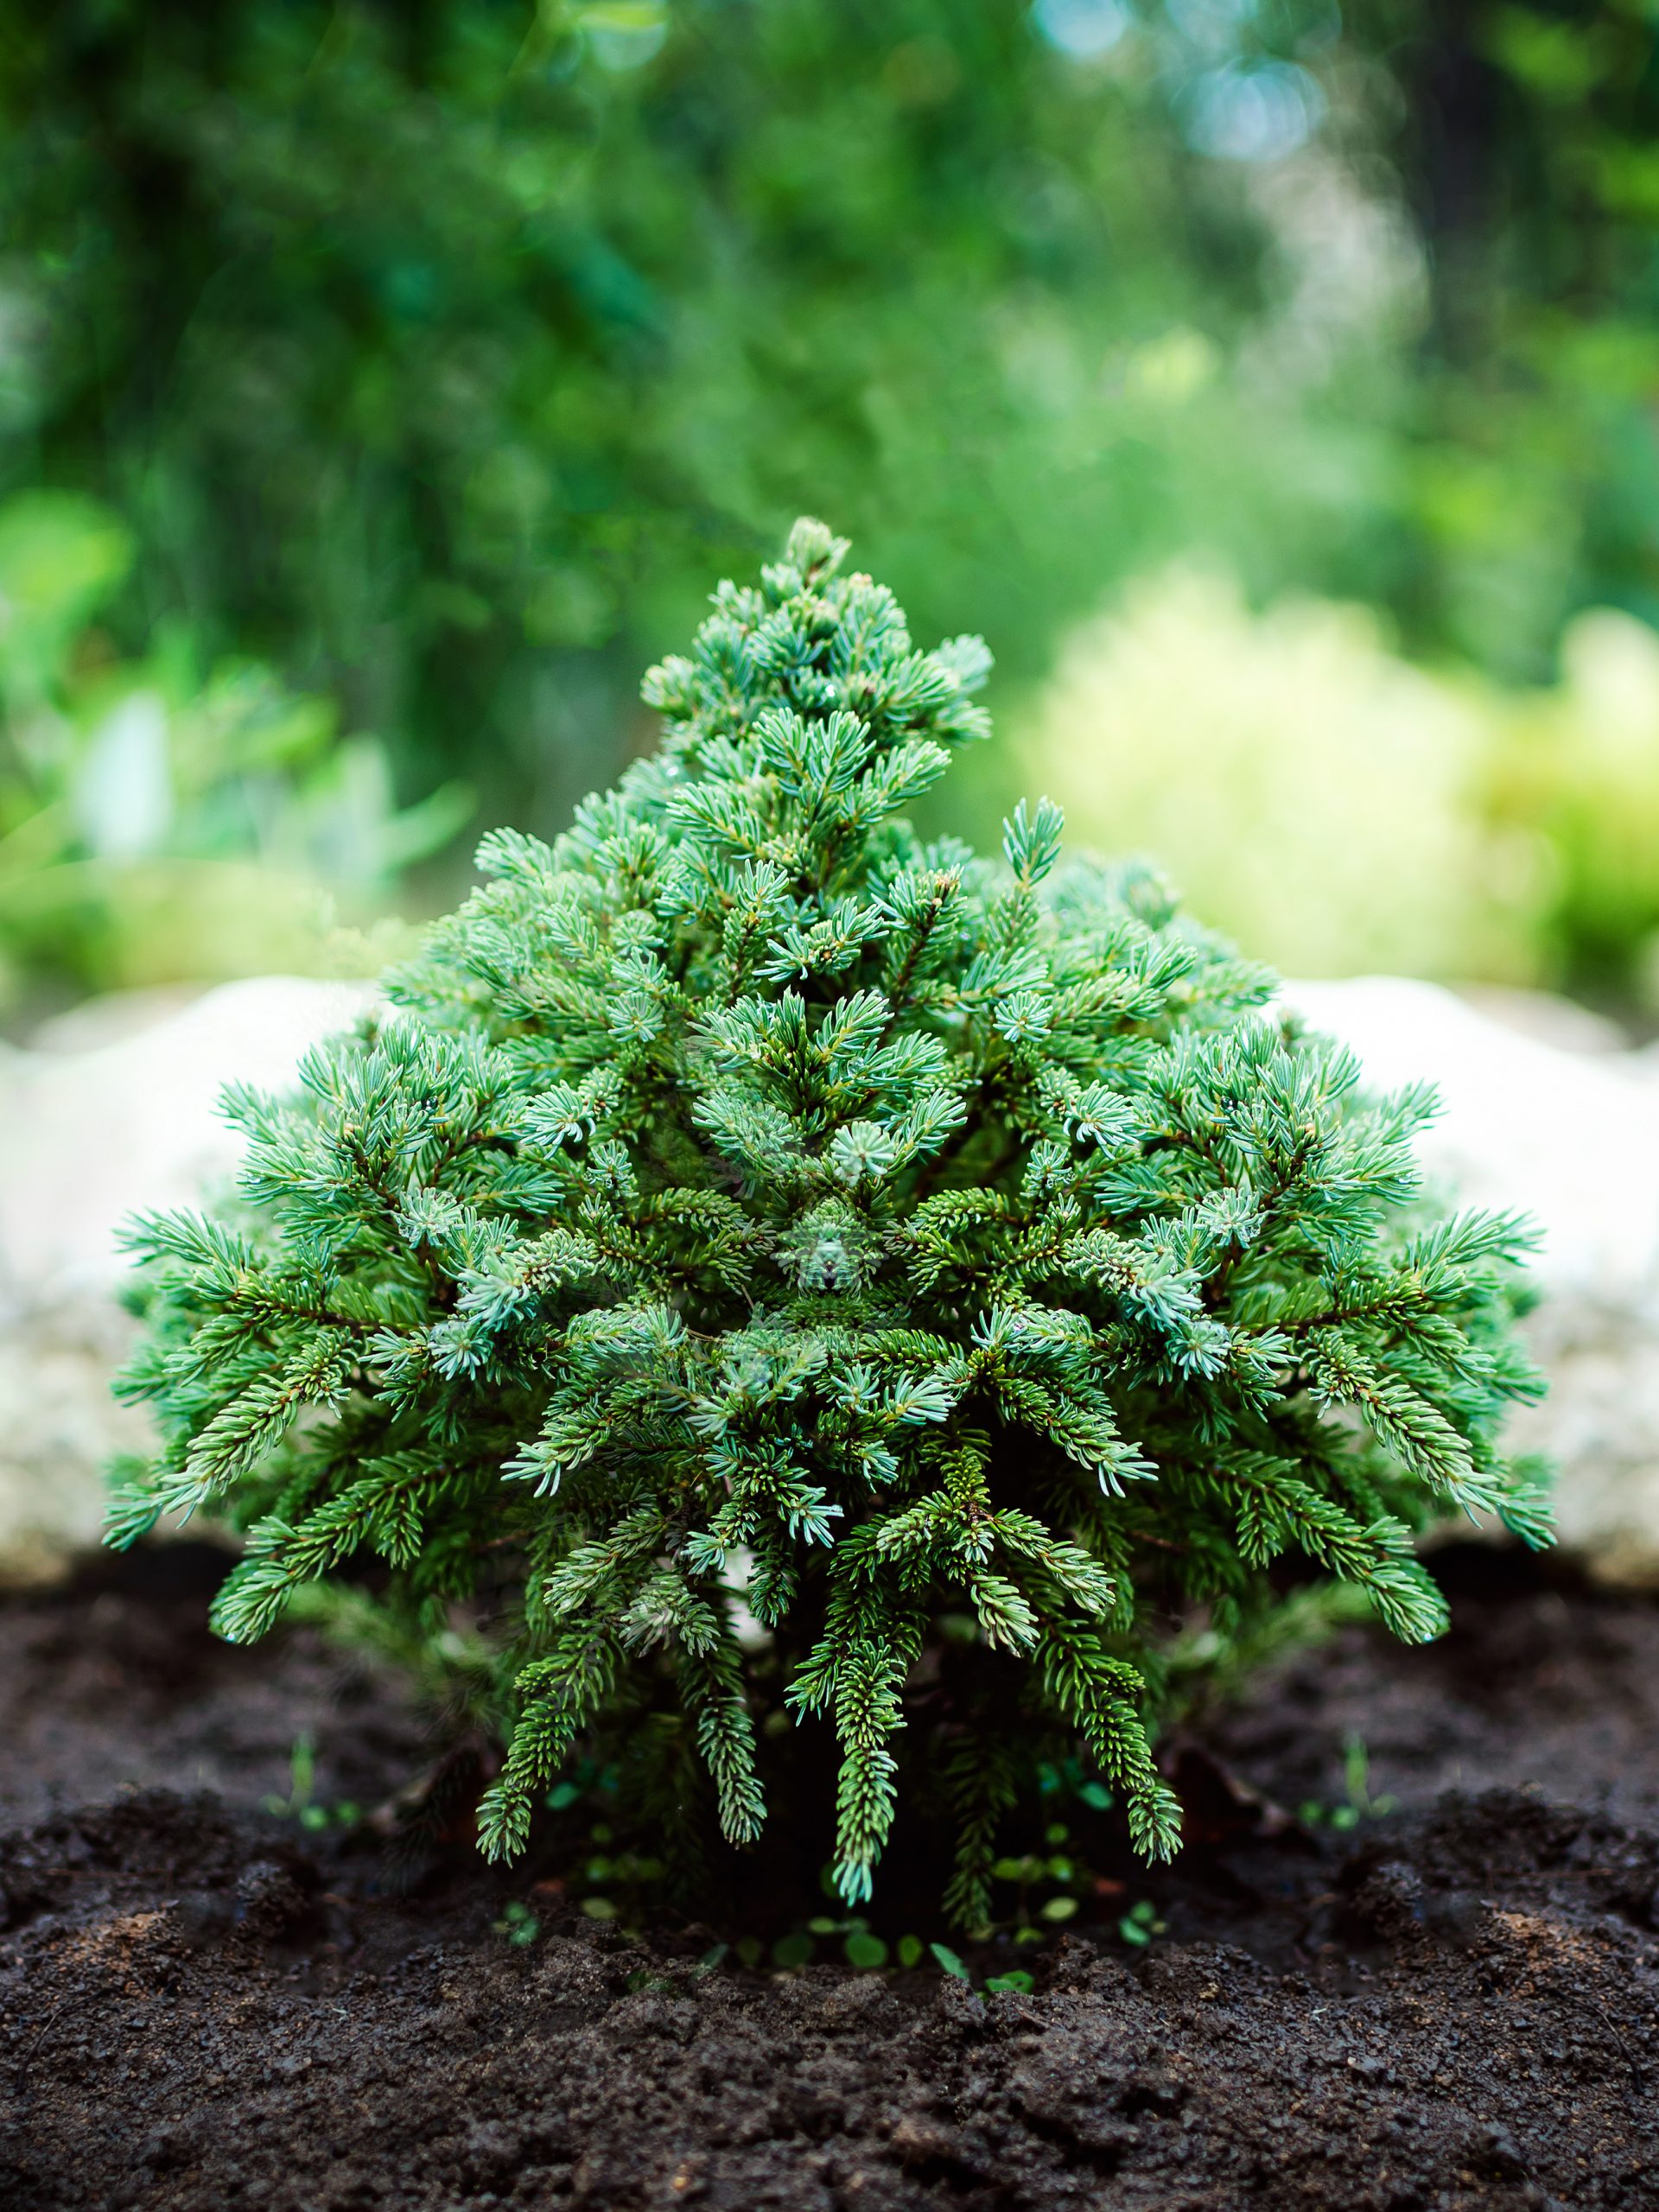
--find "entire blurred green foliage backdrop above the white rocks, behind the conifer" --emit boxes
[0,0,1659,1028]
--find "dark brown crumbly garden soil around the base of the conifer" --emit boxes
[0,1546,1659,2212]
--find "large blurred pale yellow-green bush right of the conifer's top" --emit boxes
[1020,570,1540,980]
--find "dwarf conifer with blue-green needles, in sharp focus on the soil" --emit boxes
[113,522,1541,1923]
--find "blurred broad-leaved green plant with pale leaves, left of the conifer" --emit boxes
[0,491,469,1015]
